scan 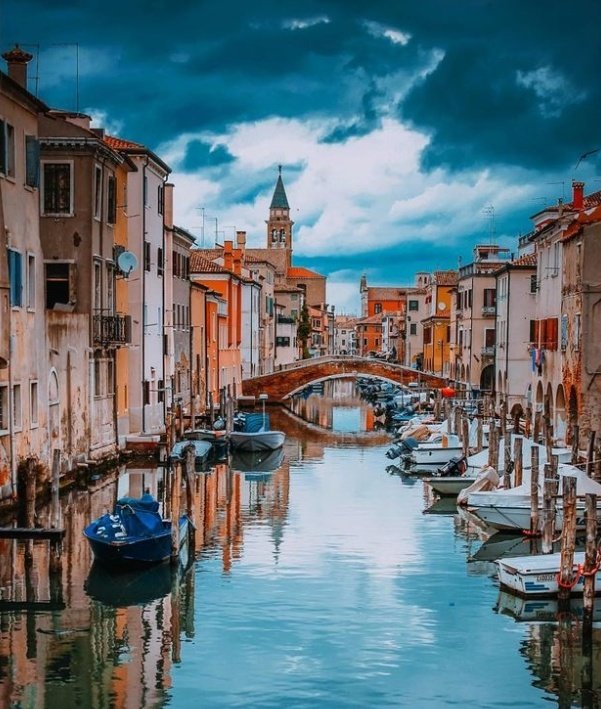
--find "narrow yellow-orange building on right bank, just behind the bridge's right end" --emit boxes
[421,271,458,376]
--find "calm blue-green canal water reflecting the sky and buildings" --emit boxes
[0,381,601,709]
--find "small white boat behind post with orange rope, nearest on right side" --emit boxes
[497,552,588,596]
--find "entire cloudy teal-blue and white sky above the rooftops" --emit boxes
[0,0,601,312]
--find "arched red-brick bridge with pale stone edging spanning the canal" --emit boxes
[242,355,447,403]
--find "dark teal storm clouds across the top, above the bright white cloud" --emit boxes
[0,0,601,170]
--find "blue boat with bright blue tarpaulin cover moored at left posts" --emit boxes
[83,493,190,567]
